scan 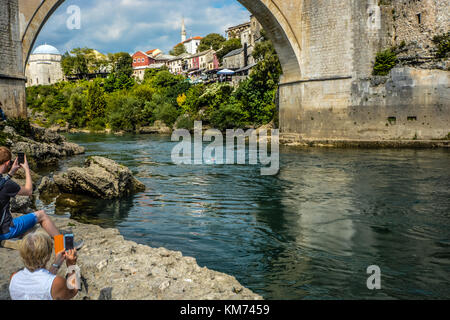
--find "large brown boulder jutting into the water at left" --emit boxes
[53,157,145,199]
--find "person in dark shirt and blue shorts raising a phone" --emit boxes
[0,147,60,241]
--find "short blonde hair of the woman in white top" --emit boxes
[19,232,53,272]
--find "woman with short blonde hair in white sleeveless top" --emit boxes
[9,232,78,300]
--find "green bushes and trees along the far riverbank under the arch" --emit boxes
[27,41,281,132]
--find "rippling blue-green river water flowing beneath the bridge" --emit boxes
[39,134,450,299]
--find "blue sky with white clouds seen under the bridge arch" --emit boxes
[35,0,250,53]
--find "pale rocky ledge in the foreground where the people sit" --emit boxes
[0,217,262,300]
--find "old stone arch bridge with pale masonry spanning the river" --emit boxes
[0,0,450,140]
